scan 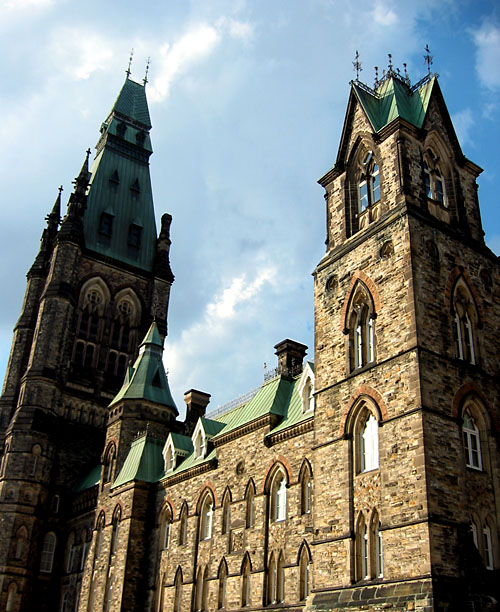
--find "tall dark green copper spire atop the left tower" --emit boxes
[84,76,156,271]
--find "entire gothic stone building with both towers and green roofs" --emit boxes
[0,61,500,612]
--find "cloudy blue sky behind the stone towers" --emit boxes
[0,0,500,416]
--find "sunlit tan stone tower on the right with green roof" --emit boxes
[313,67,500,610]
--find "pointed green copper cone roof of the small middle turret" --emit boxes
[110,322,177,414]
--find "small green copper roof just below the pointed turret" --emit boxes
[111,434,164,489]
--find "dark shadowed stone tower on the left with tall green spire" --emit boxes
[0,76,173,612]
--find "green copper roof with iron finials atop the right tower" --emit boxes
[352,77,436,132]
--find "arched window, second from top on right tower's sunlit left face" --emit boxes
[345,281,377,372]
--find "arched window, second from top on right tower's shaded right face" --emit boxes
[452,277,479,364]
